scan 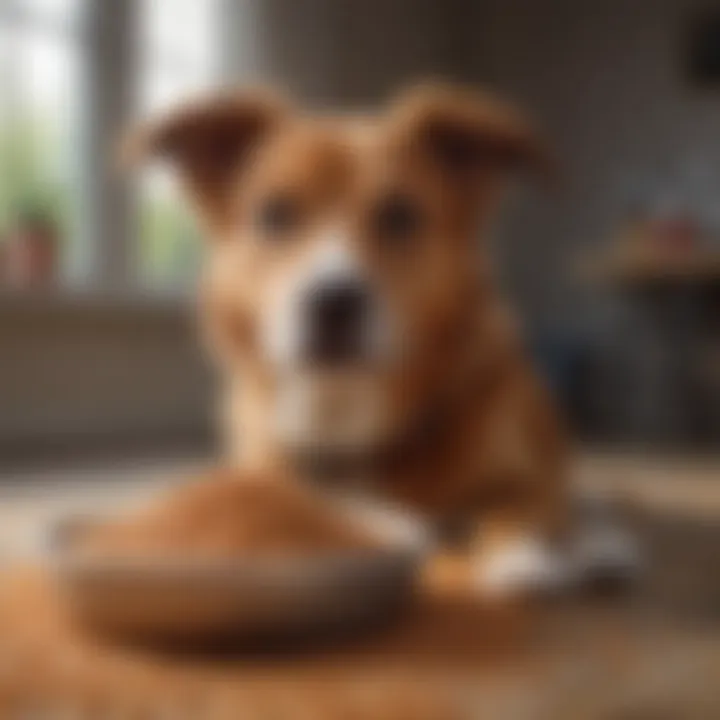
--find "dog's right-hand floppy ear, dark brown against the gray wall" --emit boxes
[395,85,552,189]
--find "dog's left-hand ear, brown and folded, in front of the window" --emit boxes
[120,91,288,224]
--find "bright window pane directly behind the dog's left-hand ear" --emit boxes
[136,0,222,288]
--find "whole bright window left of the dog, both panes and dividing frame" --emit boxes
[0,0,227,292]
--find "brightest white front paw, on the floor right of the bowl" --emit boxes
[474,536,572,599]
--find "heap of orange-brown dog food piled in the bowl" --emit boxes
[73,471,377,559]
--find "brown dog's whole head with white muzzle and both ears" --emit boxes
[129,88,540,450]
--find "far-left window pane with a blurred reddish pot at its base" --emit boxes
[0,0,82,286]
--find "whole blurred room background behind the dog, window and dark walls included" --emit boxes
[0,0,720,468]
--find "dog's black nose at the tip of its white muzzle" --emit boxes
[307,281,370,364]
